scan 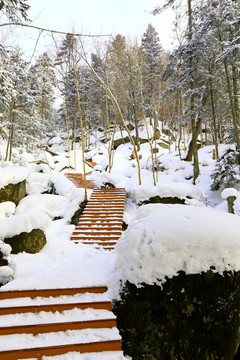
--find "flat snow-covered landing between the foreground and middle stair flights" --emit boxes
[0,215,116,291]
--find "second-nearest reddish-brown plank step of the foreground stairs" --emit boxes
[0,319,116,335]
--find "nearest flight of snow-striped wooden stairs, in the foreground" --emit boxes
[0,287,122,360]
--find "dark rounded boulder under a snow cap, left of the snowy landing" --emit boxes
[4,229,46,254]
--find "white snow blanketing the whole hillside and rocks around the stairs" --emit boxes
[0,131,240,360]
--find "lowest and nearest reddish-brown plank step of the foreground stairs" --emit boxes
[0,340,121,360]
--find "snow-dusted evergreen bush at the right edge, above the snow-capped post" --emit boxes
[211,149,240,191]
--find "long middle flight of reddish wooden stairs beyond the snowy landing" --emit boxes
[71,189,126,250]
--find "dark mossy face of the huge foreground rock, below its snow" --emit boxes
[113,271,240,360]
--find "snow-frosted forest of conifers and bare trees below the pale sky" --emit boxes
[0,0,240,188]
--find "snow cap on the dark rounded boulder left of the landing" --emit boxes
[0,211,51,239]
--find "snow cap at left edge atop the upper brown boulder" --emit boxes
[0,166,29,189]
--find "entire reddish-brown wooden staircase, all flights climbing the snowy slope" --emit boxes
[0,173,126,360]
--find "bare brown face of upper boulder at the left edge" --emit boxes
[0,180,26,205]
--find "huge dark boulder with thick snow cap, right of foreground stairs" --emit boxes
[112,204,240,360]
